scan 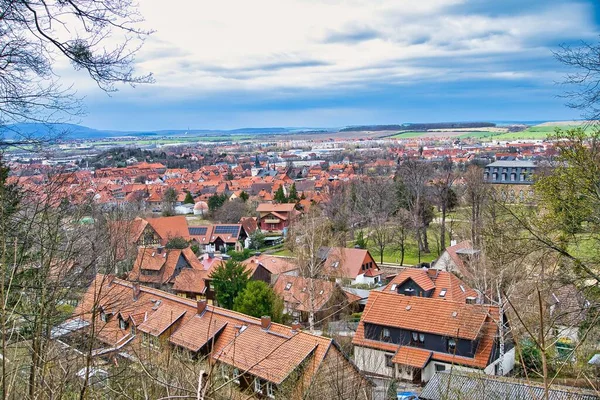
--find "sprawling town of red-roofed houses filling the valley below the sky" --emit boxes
[5,122,600,399]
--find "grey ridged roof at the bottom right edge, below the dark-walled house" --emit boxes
[420,371,600,400]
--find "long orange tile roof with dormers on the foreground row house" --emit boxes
[74,275,354,384]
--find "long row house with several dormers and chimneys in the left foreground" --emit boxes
[69,275,373,400]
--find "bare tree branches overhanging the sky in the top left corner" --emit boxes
[0,0,152,146]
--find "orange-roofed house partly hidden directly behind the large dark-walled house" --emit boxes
[383,268,481,303]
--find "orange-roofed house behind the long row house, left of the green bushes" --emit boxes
[127,246,204,289]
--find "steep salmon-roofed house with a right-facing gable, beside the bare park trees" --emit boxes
[320,247,383,285]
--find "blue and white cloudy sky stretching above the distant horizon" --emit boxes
[69,0,600,130]
